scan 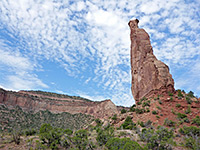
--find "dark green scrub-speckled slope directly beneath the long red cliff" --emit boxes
[0,105,93,134]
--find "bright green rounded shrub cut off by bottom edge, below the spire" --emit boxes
[106,138,143,150]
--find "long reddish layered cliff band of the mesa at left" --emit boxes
[0,89,118,118]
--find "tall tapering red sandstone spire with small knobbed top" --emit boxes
[128,19,175,102]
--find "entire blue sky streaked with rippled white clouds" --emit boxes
[0,0,200,106]
